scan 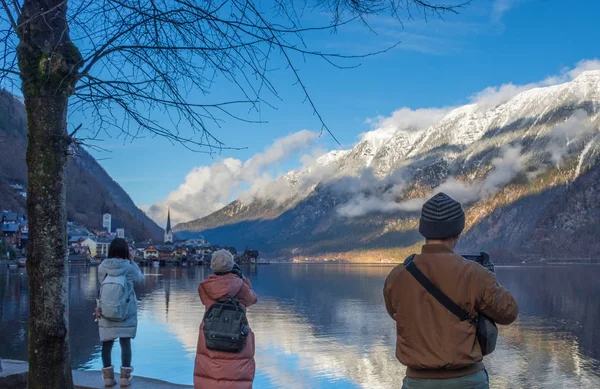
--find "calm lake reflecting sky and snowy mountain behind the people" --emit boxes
[0,264,600,389]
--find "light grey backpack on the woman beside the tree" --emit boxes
[98,274,129,321]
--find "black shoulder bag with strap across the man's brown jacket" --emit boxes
[404,254,498,355]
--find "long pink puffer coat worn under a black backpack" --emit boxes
[194,274,257,389]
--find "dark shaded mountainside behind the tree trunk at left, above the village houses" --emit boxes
[0,92,162,239]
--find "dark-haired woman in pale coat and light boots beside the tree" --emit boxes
[96,238,144,387]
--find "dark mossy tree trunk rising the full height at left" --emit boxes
[17,0,81,389]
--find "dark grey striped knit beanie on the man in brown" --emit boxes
[419,193,465,239]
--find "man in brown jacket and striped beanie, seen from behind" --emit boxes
[383,193,518,389]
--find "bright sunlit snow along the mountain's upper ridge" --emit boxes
[276,70,600,203]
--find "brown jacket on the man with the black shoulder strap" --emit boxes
[383,244,518,378]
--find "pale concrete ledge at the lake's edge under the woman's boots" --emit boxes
[0,359,193,389]
